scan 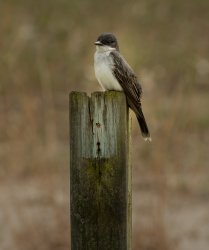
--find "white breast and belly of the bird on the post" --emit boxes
[94,51,123,91]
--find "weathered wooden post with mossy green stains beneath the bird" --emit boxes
[70,91,131,250]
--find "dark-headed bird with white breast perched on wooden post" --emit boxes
[94,33,152,142]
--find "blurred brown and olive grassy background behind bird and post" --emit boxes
[0,0,209,250]
